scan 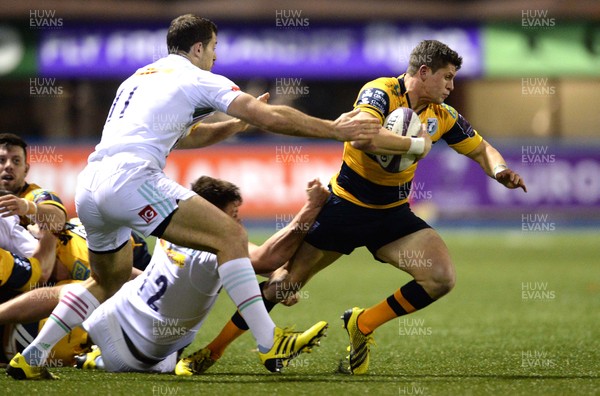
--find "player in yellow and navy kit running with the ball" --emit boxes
[199,40,527,374]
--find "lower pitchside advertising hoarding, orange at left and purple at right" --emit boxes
[28,141,600,221]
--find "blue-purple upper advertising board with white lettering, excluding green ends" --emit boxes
[38,21,483,79]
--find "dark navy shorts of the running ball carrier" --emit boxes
[304,194,431,261]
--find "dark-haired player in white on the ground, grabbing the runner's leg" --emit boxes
[78,176,329,375]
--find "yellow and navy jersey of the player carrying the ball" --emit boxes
[330,75,483,209]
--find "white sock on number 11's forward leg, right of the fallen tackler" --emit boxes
[218,258,275,352]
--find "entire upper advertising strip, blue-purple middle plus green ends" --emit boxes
[0,20,600,80]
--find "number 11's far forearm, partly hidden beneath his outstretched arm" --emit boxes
[176,93,269,149]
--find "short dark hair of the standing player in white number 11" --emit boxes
[167,14,217,54]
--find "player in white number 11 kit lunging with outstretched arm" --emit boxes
[7,14,380,379]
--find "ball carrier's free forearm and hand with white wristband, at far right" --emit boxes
[467,140,527,192]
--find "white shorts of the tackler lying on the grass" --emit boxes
[83,303,177,373]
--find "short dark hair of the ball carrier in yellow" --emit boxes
[406,40,462,76]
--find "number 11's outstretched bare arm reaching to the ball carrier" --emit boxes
[227,93,381,141]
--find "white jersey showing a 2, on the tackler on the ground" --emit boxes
[84,240,221,364]
